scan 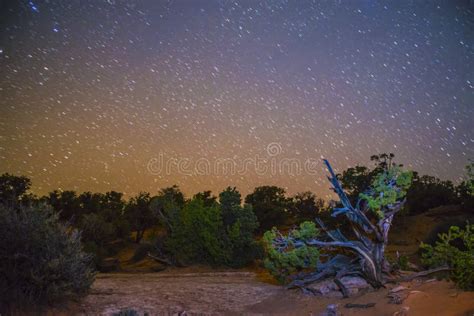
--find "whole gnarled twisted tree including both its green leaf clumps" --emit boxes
[264,156,411,287]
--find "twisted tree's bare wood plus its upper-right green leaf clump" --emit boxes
[266,160,411,294]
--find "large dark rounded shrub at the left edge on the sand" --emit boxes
[0,205,94,308]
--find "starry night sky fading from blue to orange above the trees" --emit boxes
[0,0,474,197]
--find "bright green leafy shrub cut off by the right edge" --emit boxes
[420,224,474,290]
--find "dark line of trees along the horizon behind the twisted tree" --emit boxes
[0,154,474,267]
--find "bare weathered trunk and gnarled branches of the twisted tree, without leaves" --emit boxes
[273,160,412,297]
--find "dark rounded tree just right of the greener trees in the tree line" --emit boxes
[245,186,290,232]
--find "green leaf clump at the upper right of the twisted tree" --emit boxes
[360,166,412,219]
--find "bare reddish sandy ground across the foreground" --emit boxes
[61,272,474,316]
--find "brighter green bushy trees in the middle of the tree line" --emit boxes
[151,188,261,267]
